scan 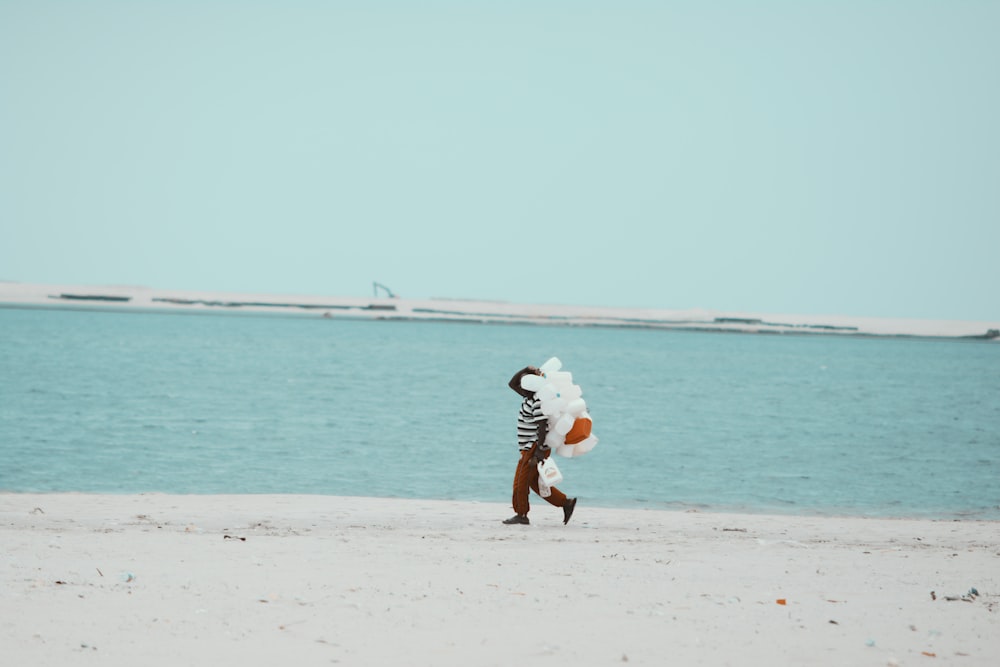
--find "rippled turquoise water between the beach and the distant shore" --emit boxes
[0,309,1000,519]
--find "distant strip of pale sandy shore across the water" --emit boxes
[0,282,1000,340]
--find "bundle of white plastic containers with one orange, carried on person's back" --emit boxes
[521,357,597,458]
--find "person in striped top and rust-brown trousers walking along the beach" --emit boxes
[504,366,576,526]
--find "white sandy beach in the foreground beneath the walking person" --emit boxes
[0,494,1000,667]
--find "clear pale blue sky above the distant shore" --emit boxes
[0,0,1000,320]
